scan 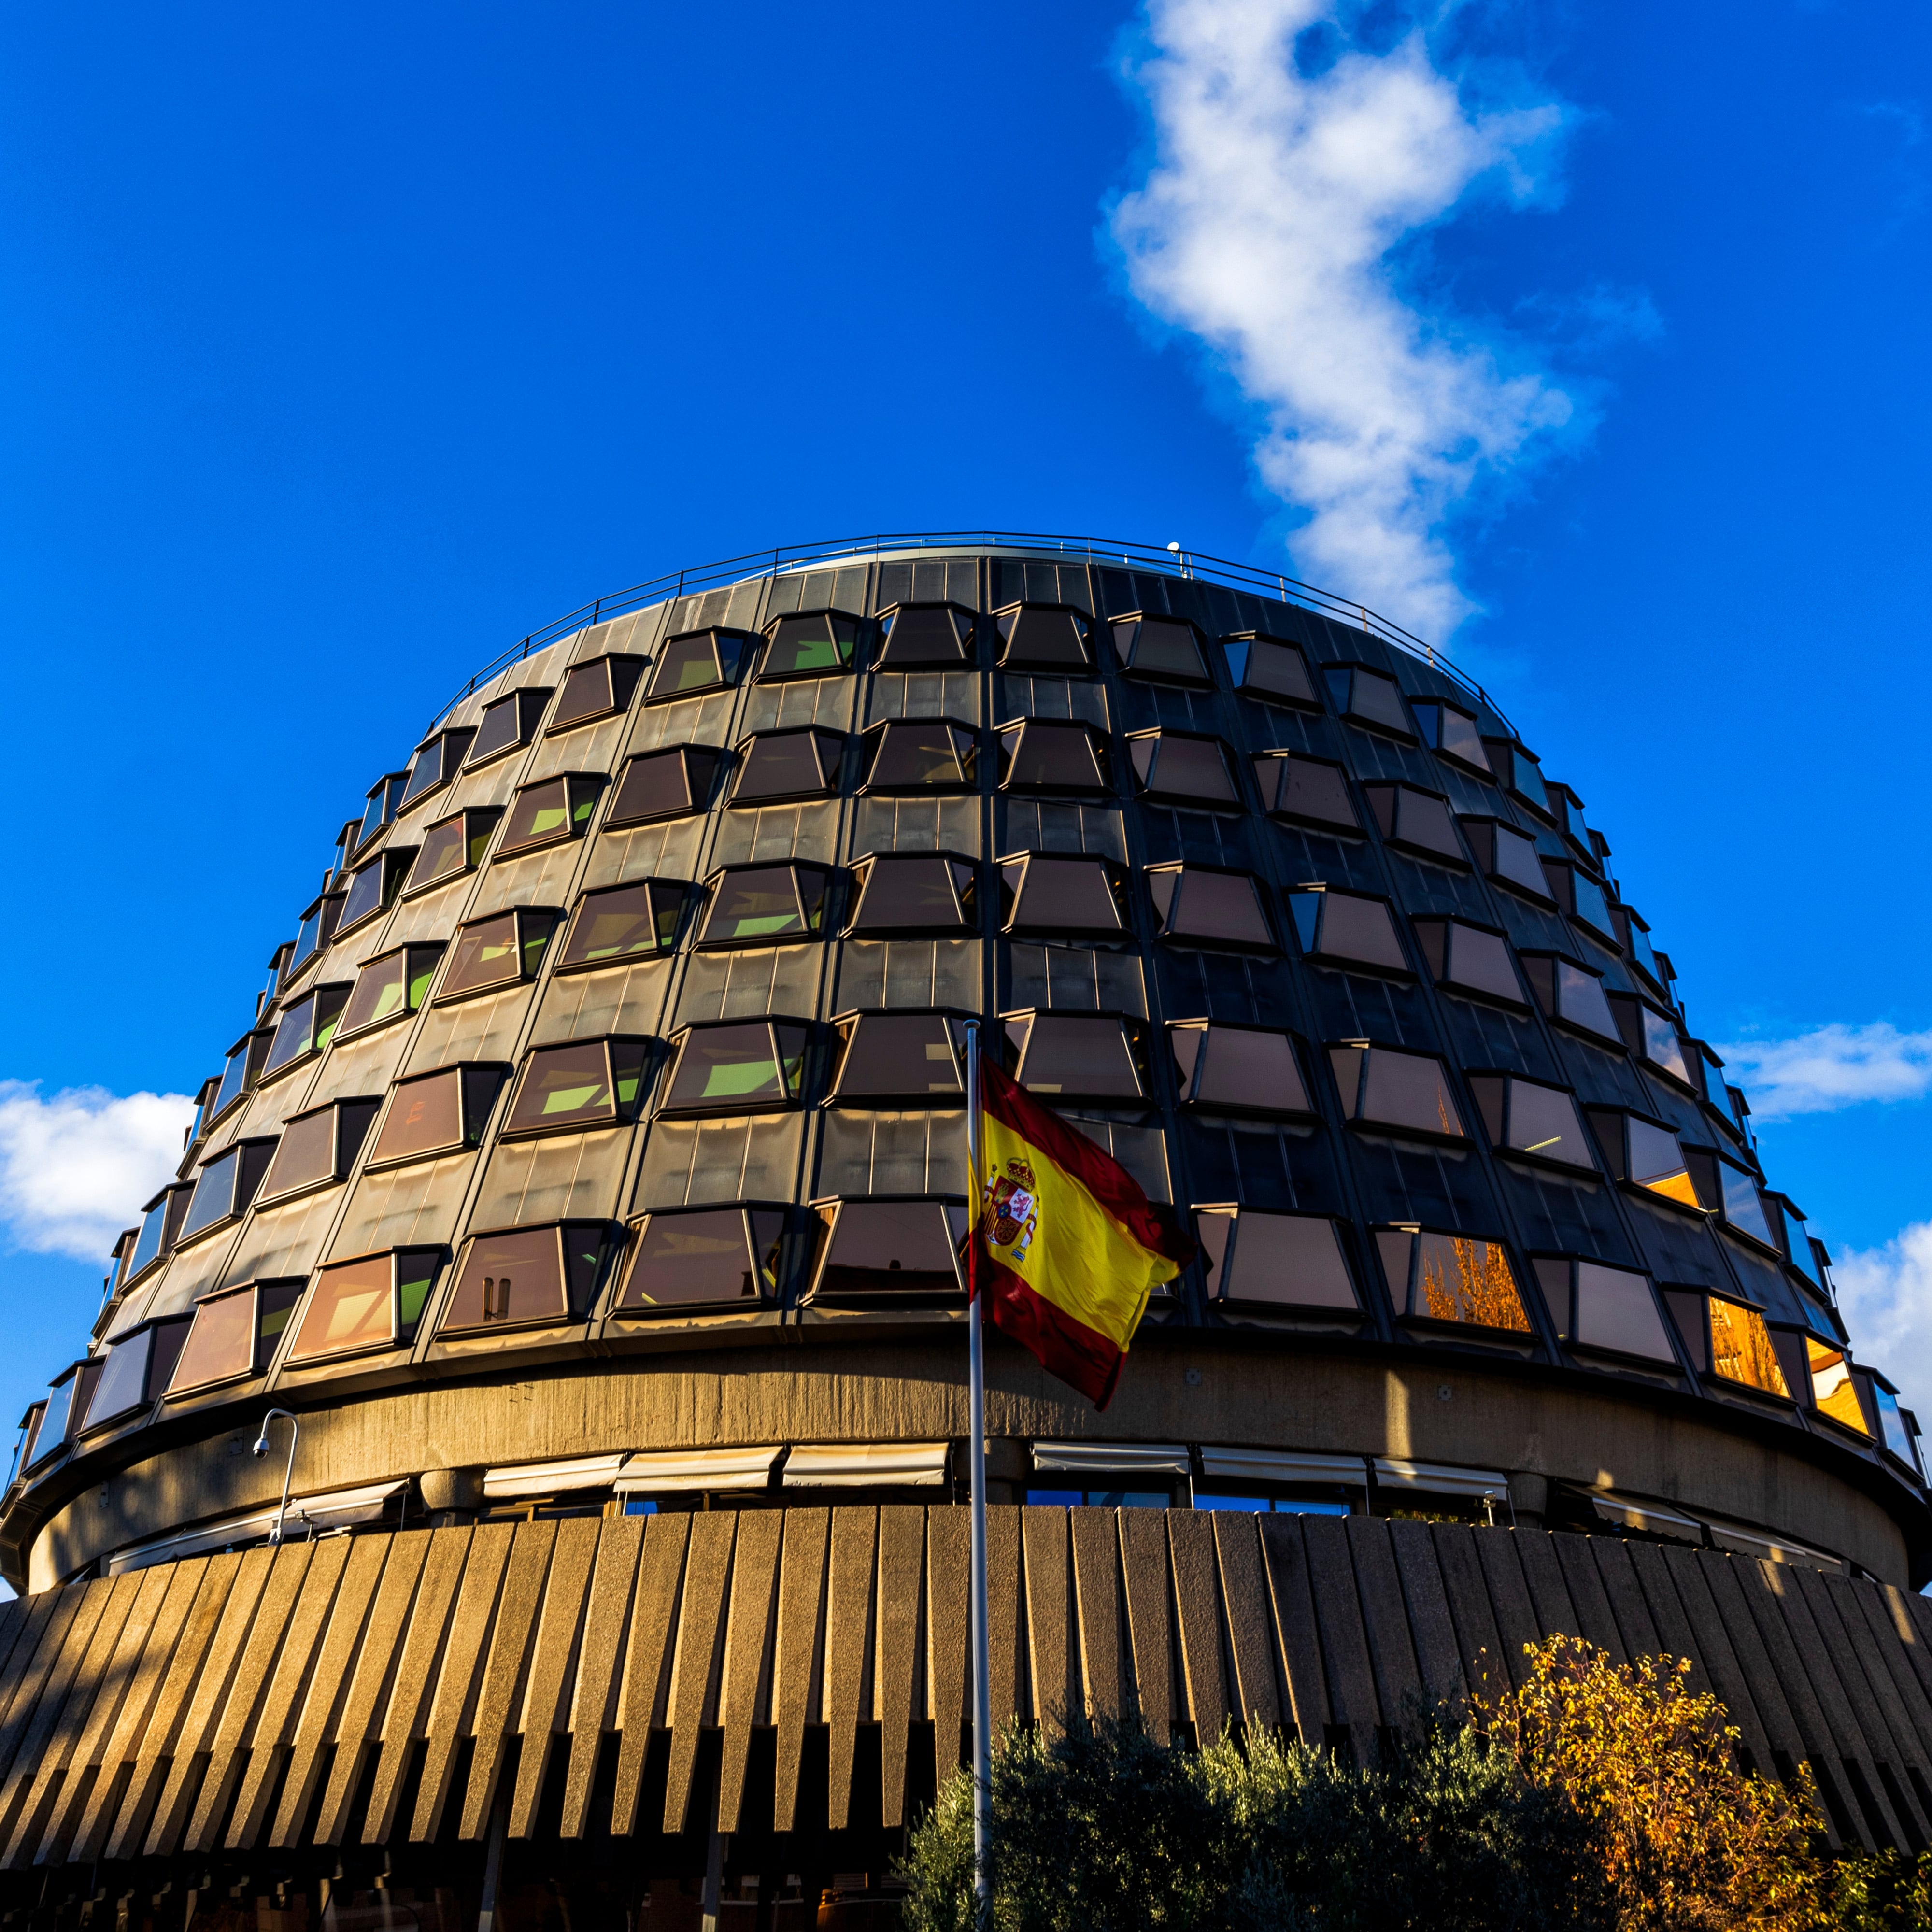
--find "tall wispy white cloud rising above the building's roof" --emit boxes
[1113,0,1577,641]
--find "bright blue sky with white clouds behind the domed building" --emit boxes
[0,0,1932,1420]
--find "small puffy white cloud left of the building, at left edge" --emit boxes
[0,1080,195,1262]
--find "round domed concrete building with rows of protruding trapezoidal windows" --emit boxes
[0,535,1932,1922]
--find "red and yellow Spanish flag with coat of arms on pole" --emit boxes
[968,1059,1194,1408]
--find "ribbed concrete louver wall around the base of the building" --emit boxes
[0,1507,1932,1870]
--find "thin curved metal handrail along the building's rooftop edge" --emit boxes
[425,529,1509,736]
